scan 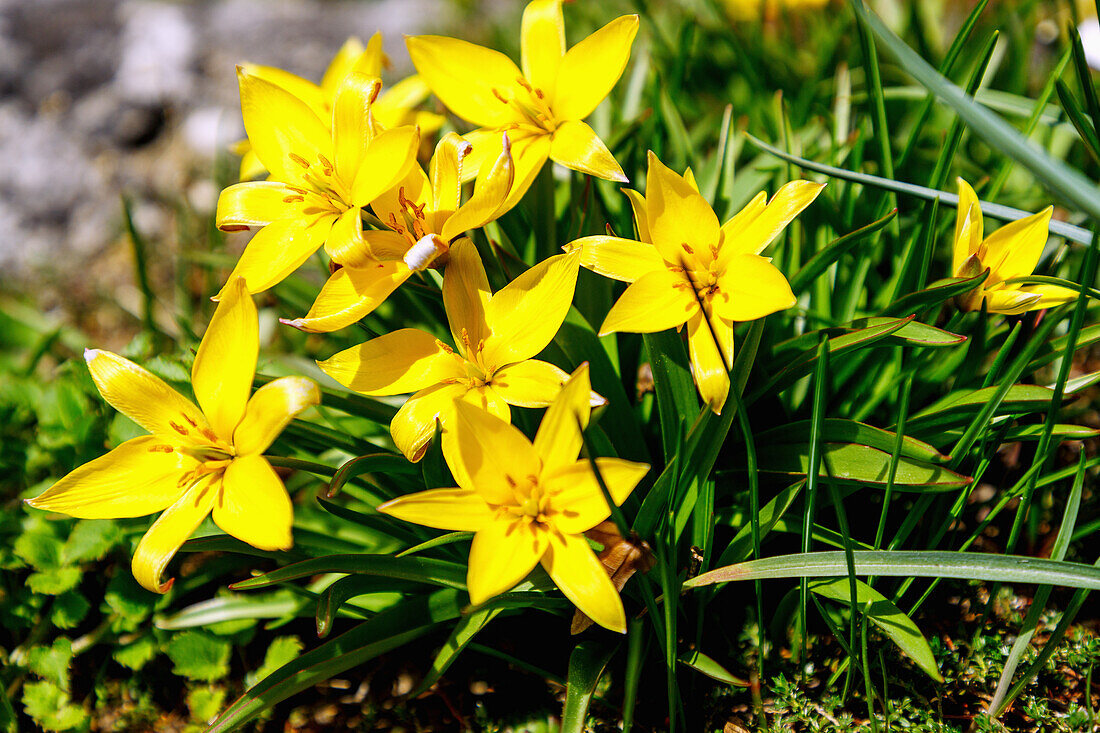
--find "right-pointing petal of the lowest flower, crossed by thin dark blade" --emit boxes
[542,458,649,535]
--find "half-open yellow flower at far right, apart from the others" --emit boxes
[952,178,1077,316]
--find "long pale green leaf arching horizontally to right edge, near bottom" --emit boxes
[683,550,1100,590]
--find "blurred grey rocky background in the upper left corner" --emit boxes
[0,0,475,346]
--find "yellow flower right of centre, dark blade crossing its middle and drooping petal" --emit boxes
[565,153,824,413]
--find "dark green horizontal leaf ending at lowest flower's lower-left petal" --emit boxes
[230,554,466,590]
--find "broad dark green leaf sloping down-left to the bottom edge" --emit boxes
[207,589,462,733]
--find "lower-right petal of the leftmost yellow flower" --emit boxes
[213,456,294,550]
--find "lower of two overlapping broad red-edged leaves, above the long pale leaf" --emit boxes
[758,442,972,491]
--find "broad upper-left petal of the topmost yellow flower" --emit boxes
[405,35,520,128]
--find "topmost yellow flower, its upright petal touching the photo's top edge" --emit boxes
[406,0,638,208]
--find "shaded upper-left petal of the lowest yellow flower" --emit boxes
[447,401,541,504]
